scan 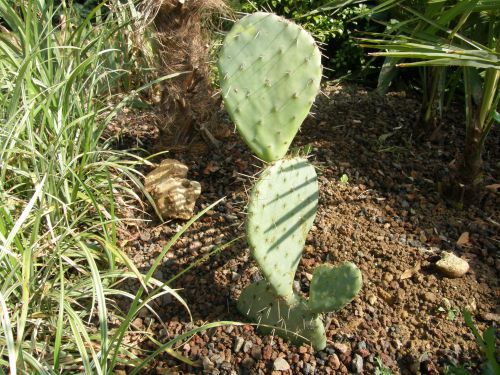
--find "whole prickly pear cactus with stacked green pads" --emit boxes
[219,12,362,350]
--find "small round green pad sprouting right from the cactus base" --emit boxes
[308,262,362,313]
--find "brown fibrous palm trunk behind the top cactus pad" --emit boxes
[154,0,228,144]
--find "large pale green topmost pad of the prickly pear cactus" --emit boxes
[218,12,322,162]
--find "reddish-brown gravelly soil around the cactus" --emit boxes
[114,85,500,374]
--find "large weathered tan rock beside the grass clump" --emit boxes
[144,159,201,220]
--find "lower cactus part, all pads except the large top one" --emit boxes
[238,157,361,350]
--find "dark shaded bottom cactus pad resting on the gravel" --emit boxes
[238,280,326,350]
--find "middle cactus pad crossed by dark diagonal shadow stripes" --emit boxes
[247,157,318,297]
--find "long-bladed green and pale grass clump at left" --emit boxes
[0,0,229,374]
